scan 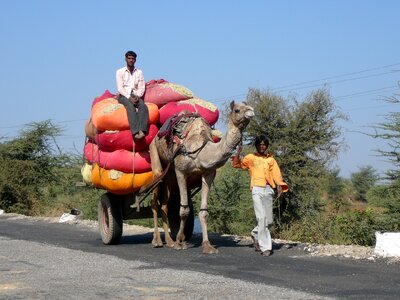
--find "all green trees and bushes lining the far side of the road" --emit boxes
[0,89,400,245]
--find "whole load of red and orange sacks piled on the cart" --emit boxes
[81,79,220,194]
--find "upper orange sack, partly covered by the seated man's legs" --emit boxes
[91,98,159,131]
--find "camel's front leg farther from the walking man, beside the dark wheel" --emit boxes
[174,169,190,250]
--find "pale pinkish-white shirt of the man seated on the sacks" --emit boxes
[116,67,145,99]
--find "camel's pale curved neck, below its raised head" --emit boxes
[199,120,242,169]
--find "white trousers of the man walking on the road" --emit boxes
[251,185,274,252]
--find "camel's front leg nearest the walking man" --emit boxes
[199,173,218,254]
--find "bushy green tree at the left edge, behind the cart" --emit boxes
[0,121,69,214]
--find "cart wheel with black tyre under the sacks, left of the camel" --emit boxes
[98,193,122,245]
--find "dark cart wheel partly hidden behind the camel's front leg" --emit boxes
[168,194,194,241]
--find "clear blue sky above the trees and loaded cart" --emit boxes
[0,0,400,178]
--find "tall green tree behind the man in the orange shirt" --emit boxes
[245,89,345,224]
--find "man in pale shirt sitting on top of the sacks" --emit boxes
[116,51,149,140]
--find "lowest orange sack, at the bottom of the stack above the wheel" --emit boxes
[92,164,153,195]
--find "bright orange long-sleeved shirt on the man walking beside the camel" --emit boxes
[232,153,289,192]
